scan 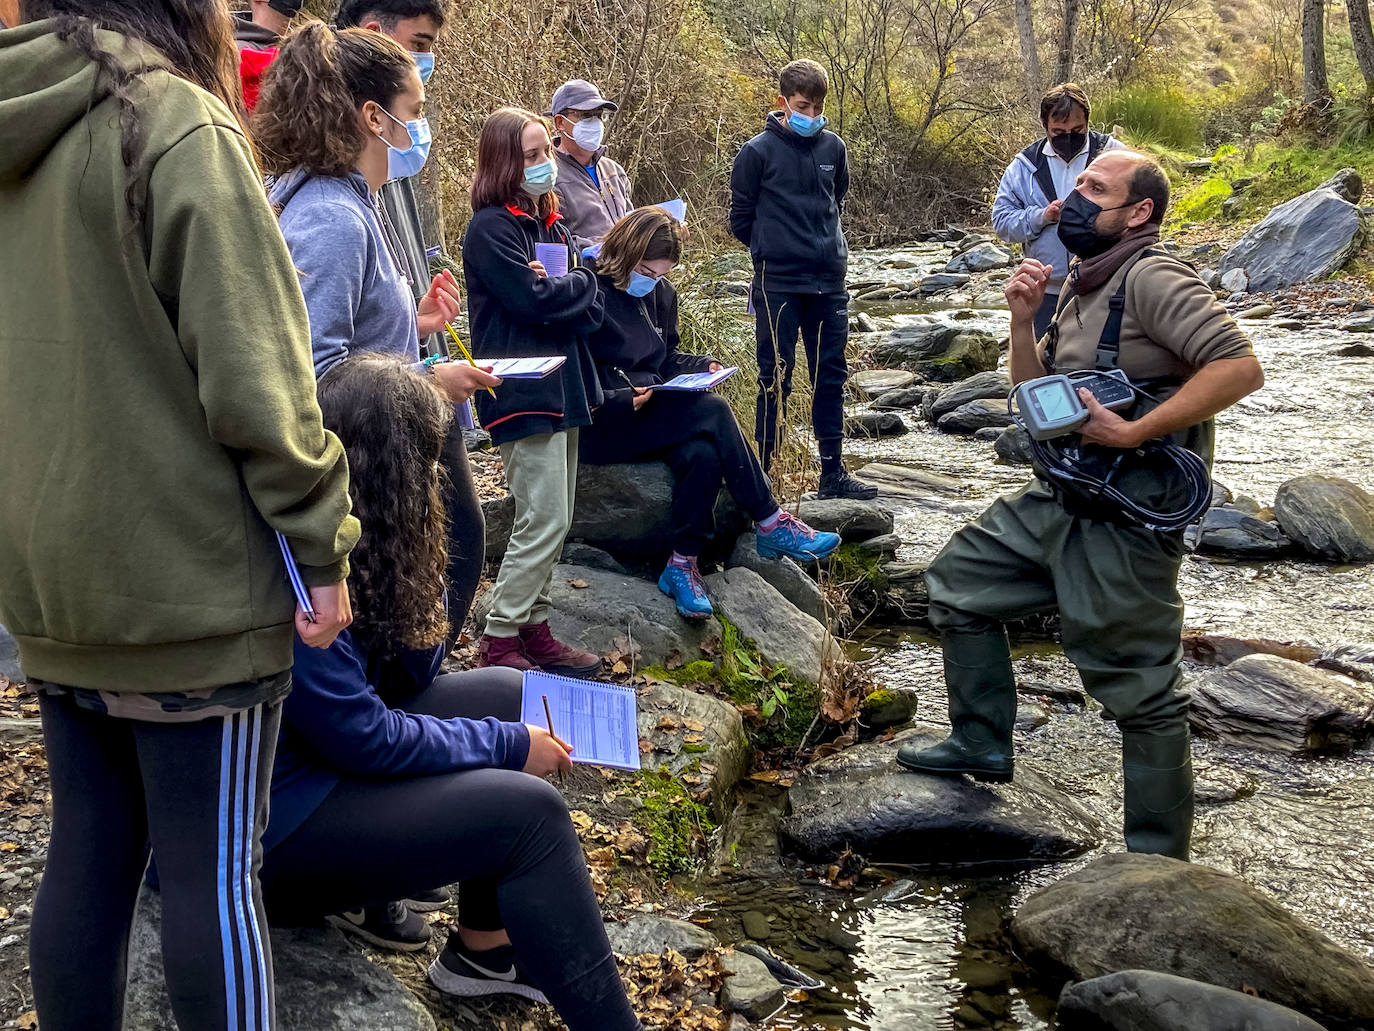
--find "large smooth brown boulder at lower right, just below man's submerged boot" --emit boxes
[1011,852,1374,1027]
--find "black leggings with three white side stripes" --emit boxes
[29,694,282,1031]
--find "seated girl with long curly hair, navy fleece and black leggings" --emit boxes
[262,356,640,1031]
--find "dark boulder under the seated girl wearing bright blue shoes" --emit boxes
[482,462,749,561]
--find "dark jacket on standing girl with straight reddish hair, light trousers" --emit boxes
[463,206,602,444]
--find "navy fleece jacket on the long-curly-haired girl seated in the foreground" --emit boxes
[262,630,529,848]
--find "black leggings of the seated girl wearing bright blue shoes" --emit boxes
[577,390,778,555]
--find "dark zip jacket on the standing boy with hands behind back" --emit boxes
[730,111,849,294]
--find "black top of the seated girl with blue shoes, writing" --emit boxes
[588,258,717,414]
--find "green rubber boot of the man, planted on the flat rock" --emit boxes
[897,630,1017,784]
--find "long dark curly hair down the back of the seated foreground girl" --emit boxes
[319,355,453,653]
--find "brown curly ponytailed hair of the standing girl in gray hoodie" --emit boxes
[249,21,419,176]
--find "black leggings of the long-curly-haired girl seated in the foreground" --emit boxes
[262,667,640,1031]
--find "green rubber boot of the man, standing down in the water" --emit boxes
[1121,730,1193,862]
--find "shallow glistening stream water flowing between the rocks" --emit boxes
[681,245,1374,1031]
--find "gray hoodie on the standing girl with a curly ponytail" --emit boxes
[271,169,420,377]
